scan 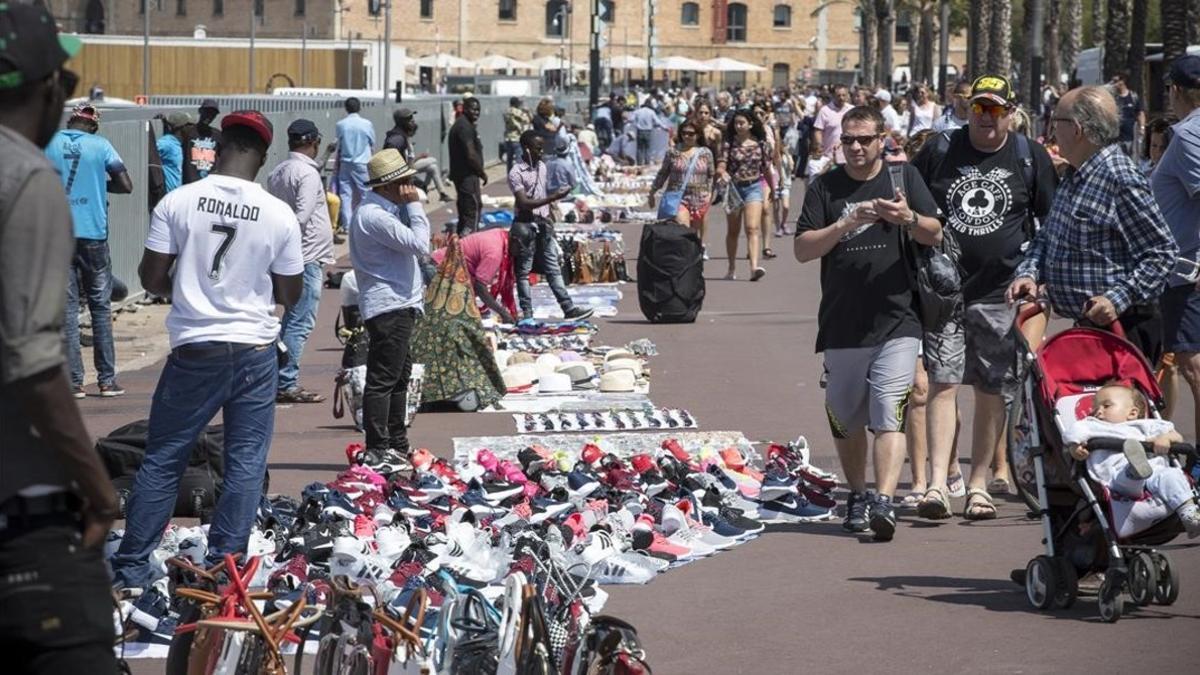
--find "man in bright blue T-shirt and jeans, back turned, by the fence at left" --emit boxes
[46,103,133,399]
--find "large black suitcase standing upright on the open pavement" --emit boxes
[637,220,704,323]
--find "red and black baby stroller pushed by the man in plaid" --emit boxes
[1008,303,1195,622]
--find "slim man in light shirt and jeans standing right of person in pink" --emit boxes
[509,130,593,319]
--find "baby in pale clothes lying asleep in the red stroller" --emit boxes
[1063,383,1200,537]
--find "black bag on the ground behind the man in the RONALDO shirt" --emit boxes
[96,419,270,519]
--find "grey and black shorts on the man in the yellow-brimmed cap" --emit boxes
[924,297,1019,396]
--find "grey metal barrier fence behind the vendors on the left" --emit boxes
[93,96,587,298]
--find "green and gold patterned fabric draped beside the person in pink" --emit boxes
[412,237,505,408]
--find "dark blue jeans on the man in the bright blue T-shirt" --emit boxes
[64,239,116,387]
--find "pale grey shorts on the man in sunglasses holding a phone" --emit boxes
[824,338,920,438]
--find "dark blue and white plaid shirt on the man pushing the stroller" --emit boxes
[1015,144,1180,319]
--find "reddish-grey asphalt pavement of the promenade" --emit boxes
[88,176,1200,674]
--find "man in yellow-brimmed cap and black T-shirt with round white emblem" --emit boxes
[913,76,1057,519]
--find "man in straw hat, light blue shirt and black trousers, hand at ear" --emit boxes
[349,148,430,474]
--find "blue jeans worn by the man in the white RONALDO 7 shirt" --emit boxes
[112,342,278,587]
